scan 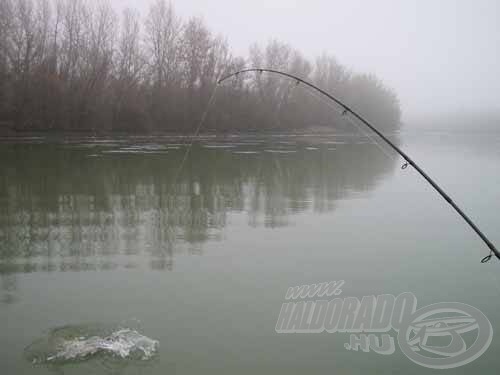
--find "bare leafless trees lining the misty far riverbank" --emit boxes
[0,0,401,132]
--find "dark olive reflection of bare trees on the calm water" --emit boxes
[0,136,397,298]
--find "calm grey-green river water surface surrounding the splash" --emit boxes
[0,133,500,374]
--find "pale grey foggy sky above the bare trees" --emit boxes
[112,0,500,119]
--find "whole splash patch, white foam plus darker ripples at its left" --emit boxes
[25,326,159,364]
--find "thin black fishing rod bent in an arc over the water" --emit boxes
[217,68,500,263]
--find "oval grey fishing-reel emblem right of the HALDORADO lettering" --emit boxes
[398,302,493,369]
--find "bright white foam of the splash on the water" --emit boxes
[47,329,159,362]
